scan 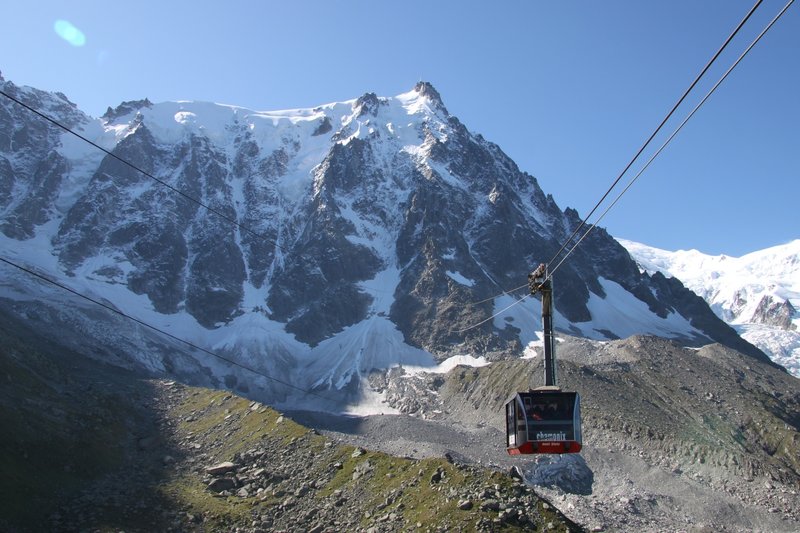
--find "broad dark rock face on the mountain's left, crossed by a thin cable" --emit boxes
[54,124,245,327]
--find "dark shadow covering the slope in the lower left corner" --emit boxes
[0,302,184,532]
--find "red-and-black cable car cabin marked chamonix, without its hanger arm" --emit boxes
[506,387,583,455]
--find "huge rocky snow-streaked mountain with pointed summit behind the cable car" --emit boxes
[0,74,766,400]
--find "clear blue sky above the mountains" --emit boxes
[0,0,800,256]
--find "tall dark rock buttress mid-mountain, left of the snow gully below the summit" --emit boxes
[267,139,390,344]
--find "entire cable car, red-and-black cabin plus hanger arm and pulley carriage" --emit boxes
[506,263,583,455]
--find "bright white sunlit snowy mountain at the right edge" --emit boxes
[617,239,800,377]
